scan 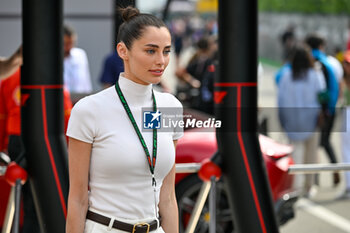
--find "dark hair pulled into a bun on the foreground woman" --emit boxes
[117,6,167,50]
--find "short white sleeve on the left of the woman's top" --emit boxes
[67,97,96,143]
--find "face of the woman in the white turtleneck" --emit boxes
[117,26,171,85]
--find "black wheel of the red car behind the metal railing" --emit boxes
[176,174,234,233]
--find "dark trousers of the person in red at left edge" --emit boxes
[8,135,40,233]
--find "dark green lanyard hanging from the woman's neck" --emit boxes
[115,82,157,186]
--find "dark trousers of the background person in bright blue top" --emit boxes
[321,113,337,163]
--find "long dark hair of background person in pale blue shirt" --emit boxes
[291,44,314,80]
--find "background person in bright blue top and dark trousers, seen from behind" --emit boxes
[305,34,340,185]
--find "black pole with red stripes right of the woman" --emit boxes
[215,0,278,233]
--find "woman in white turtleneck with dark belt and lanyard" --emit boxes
[66,7,183,233]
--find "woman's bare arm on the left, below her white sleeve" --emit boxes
[66,138,92,233]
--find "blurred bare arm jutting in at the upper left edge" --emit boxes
[0,46,23,80]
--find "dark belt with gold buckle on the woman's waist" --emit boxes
[86,210,158,233]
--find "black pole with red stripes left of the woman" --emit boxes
[21,0,68,233]
